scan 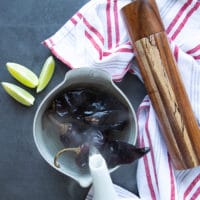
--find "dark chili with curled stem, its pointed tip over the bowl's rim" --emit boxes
[54,141,150,169]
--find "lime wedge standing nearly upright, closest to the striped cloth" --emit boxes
[36,56,55,93]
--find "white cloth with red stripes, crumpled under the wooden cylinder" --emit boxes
[43,0,200,200]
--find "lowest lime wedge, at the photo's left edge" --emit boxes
[1,82,35,106]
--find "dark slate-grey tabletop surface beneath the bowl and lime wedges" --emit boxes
[0,0,145,200]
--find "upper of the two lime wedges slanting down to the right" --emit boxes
[6,62,38,88]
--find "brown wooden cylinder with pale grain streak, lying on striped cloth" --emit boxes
[122,0,200,170]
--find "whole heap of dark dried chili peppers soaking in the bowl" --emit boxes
[48,88,149,168]
